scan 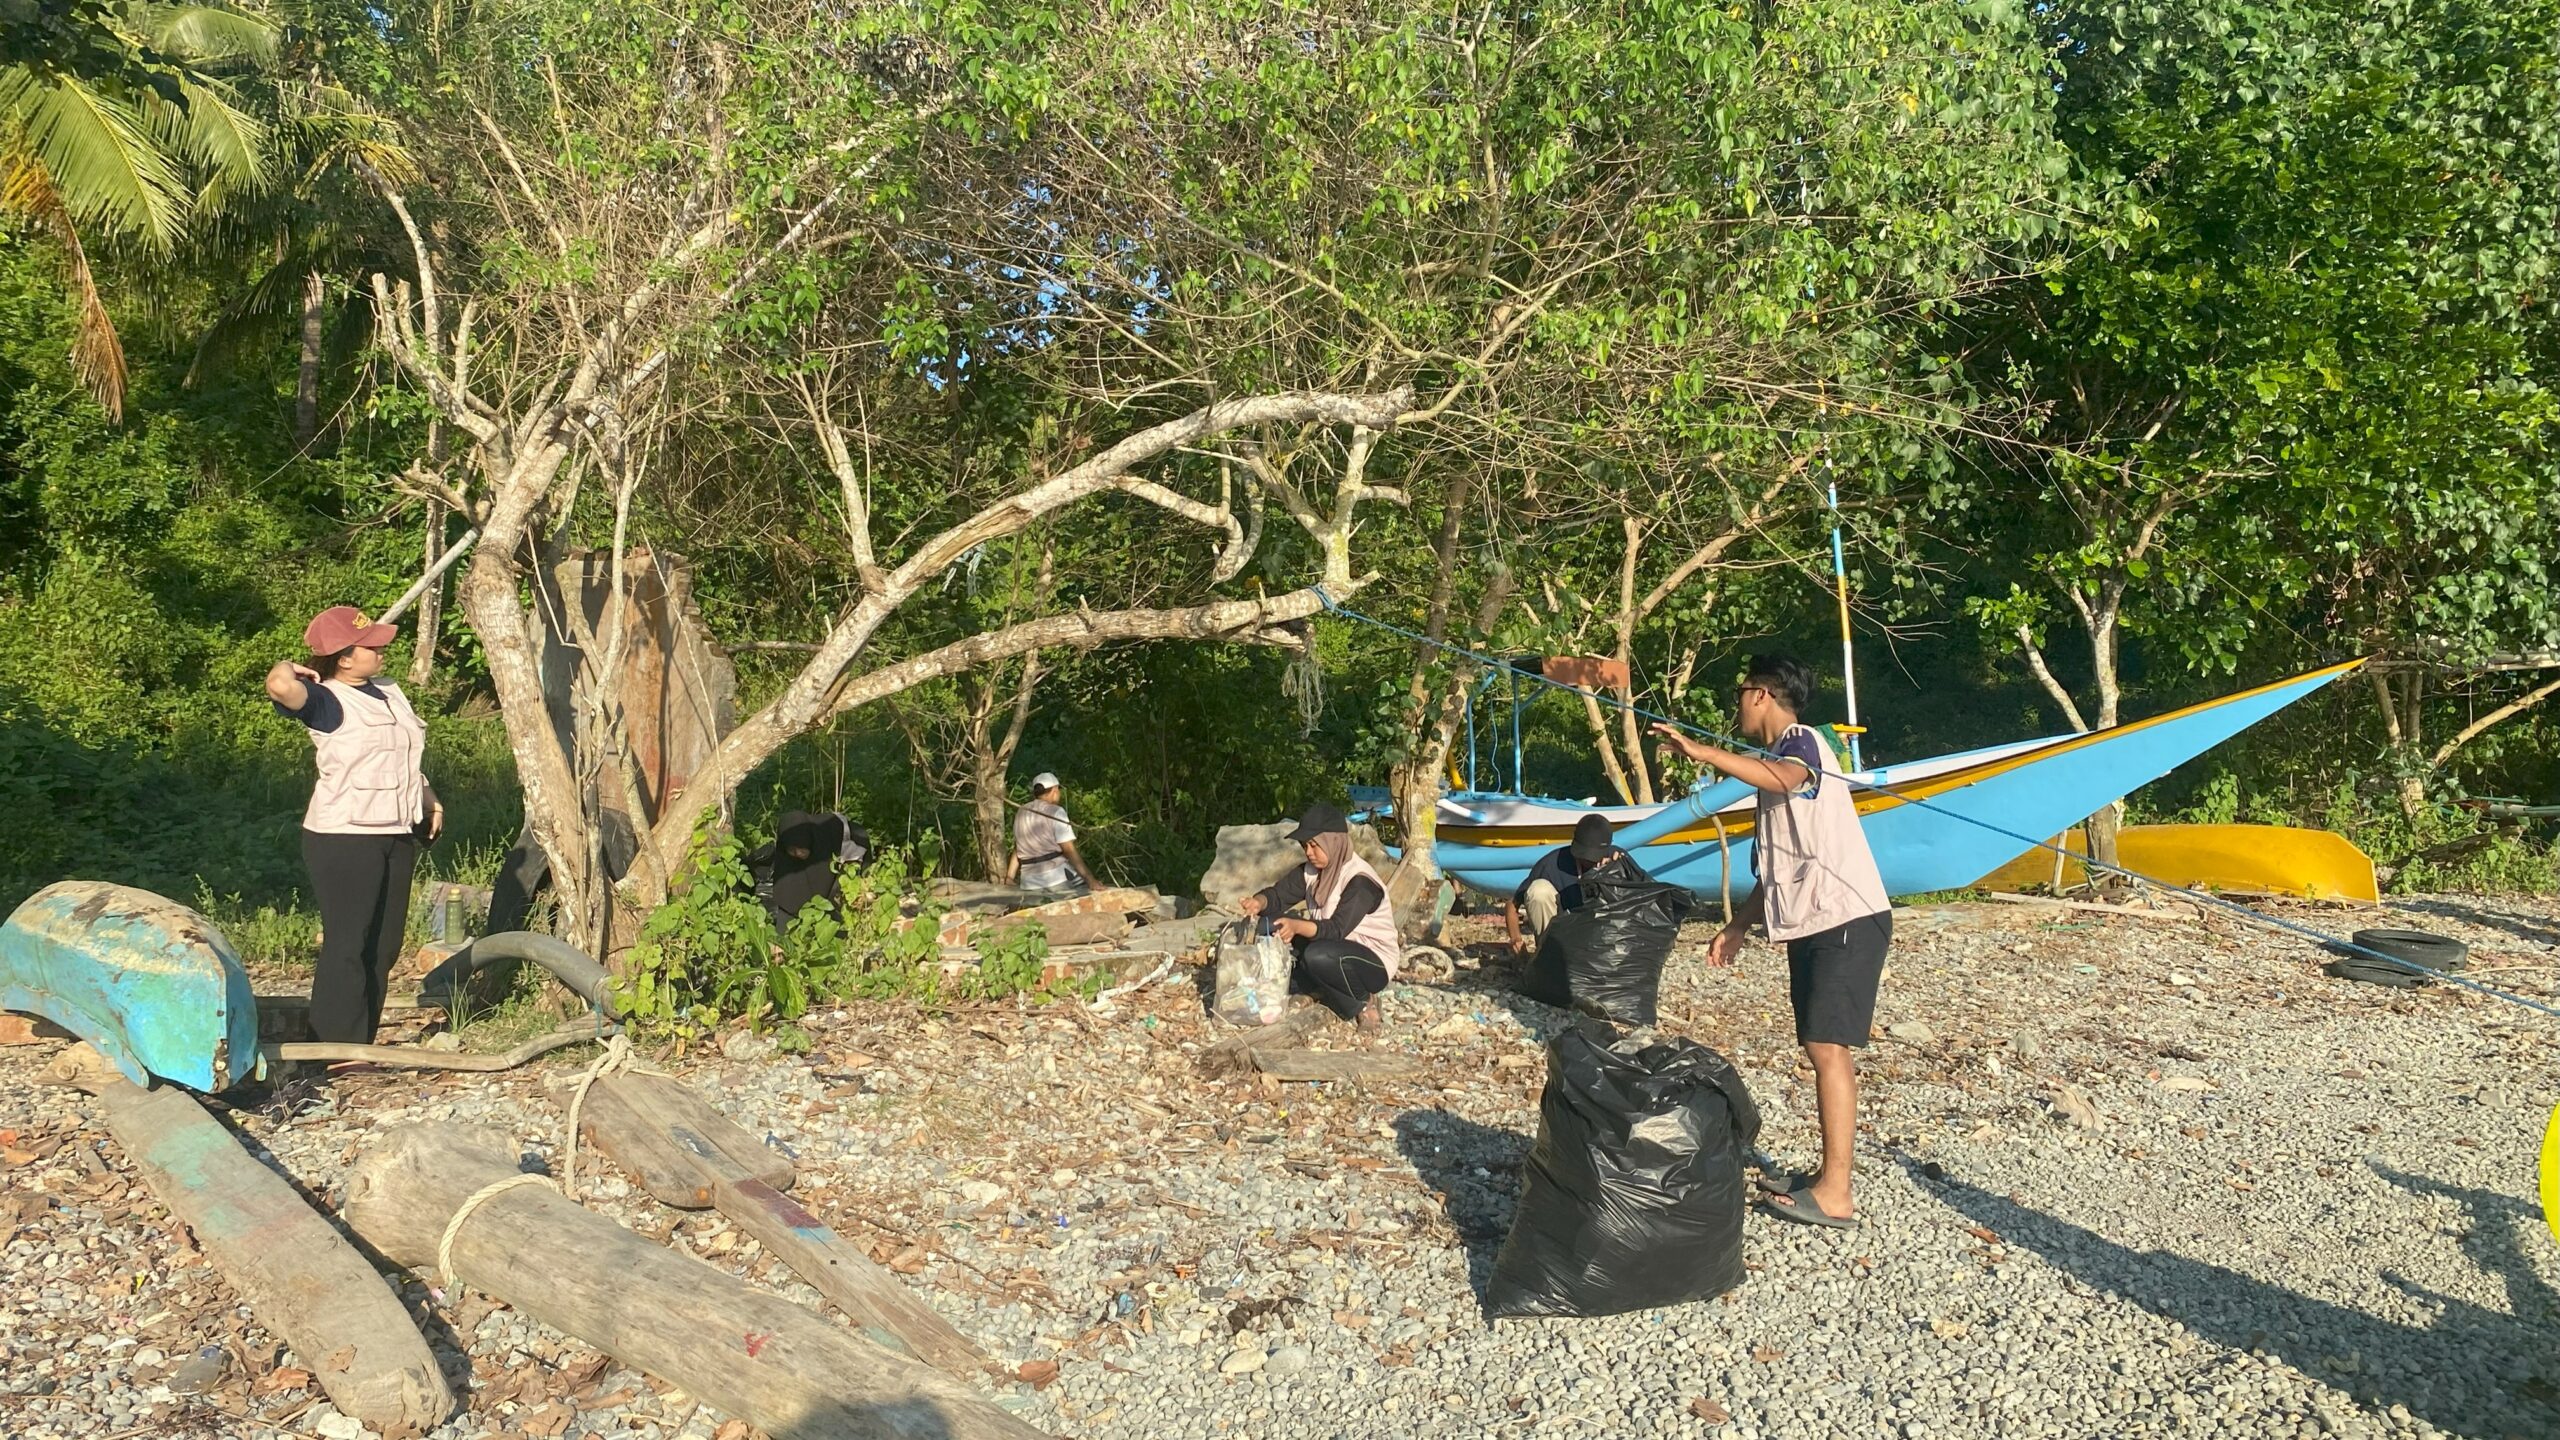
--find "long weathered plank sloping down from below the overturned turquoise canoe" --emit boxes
[56,1045,453,1430]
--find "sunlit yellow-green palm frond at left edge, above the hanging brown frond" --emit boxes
[0,67,189,254]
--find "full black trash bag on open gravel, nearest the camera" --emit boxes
[1485,1027,1759,1320]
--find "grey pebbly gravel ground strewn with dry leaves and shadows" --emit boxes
[0,897,2560,1440]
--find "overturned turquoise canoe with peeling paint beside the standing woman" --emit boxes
[0,879,266,1092]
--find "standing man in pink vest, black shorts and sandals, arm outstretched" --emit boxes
[1654,656,1894,1230]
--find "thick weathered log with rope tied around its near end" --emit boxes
[346,1125,1039,1440]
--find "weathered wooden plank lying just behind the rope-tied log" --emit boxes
[579,1074,986,1376]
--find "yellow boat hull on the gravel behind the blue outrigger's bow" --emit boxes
[1976,825,2381,904]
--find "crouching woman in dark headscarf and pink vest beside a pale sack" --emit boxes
[1244,805,1403,1030]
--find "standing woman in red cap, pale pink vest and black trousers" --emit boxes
[266,605,445,1045]
